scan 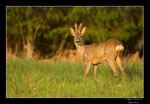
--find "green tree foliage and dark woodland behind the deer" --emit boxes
[7,7,143,56]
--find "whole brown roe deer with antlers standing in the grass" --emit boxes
[70,23,125,79]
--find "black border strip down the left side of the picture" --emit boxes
[0,5,6,101]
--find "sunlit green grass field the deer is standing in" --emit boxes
[6,58,144,98]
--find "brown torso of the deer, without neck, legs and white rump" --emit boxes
[83,39,122,64]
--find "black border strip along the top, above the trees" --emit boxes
[5,0,144,6]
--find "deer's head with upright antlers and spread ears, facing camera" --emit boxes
[70,23,86,44]
